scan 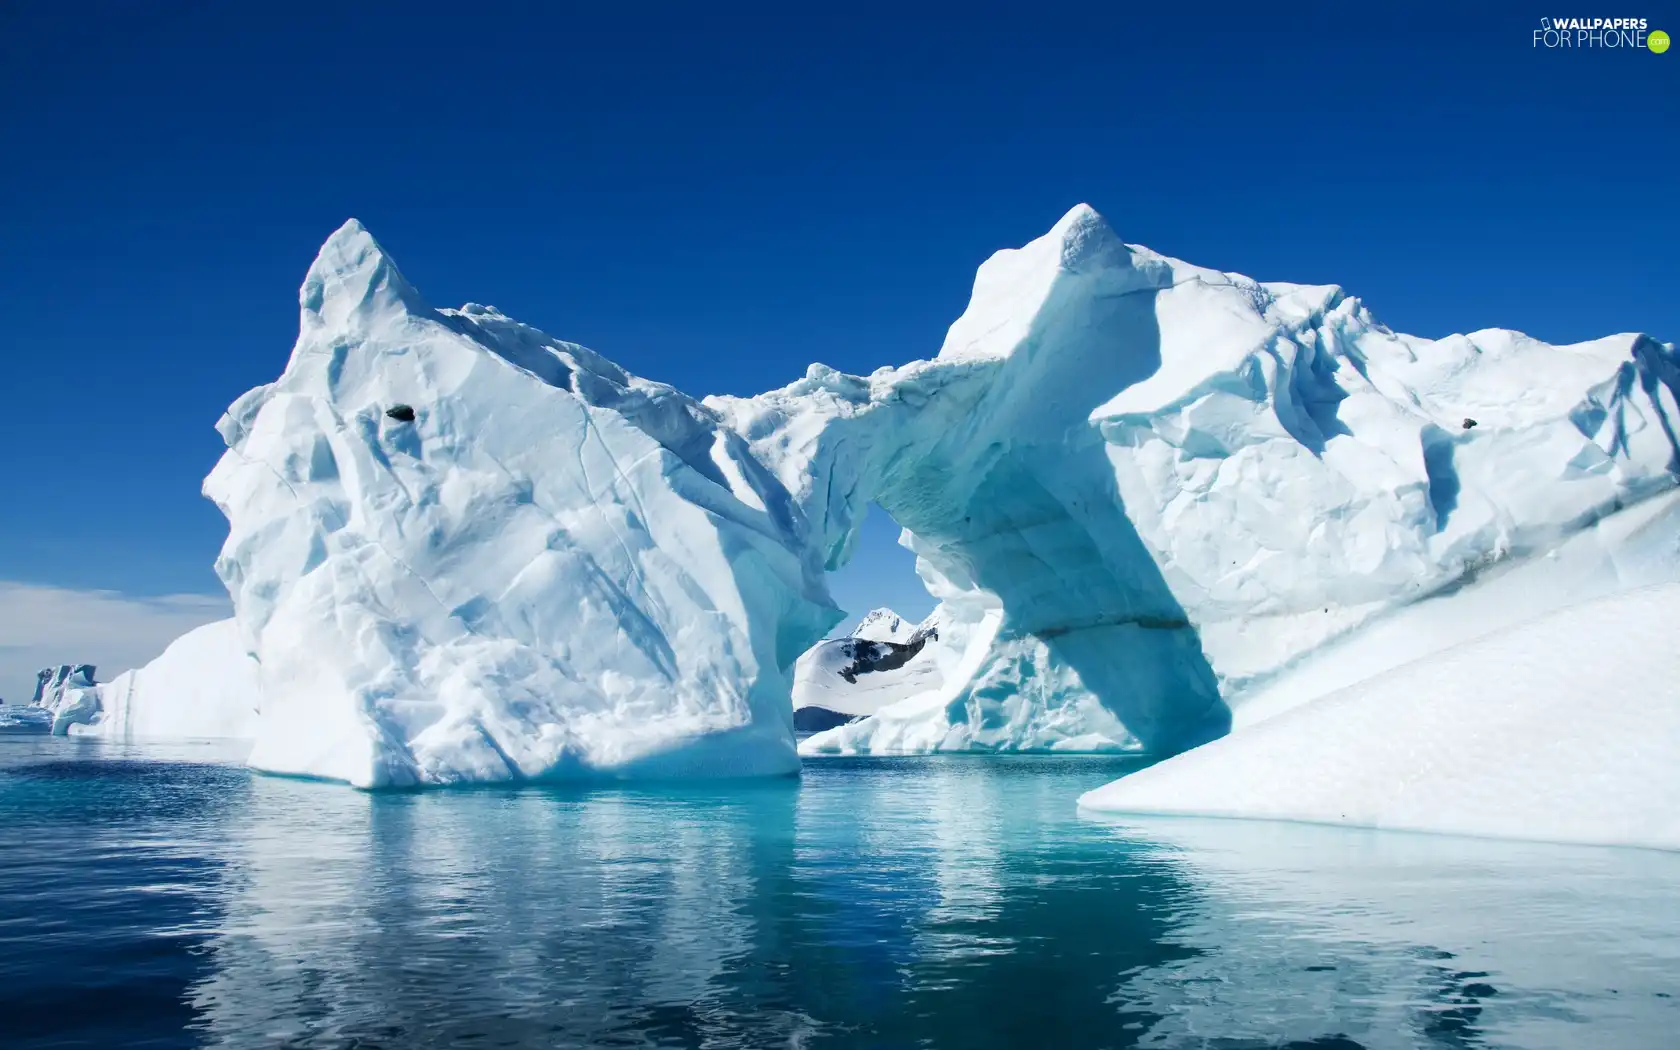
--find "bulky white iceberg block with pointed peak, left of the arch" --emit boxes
[205,220,842,786]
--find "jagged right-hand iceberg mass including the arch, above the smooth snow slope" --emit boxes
[707,207,1680,753]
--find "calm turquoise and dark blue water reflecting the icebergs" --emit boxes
[0,736,1680,1050]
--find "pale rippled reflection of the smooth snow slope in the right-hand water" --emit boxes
[1088,818,1680,1050]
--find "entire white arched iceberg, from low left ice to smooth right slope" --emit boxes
[36,207,1680,847]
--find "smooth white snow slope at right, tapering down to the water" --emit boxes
[1079,583,1680,850]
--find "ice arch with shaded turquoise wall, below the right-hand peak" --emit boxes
[707,208,1228,749]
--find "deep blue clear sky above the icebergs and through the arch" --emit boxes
[0,0,1680,659]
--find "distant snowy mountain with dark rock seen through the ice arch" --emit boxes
[793,608,942,731]
